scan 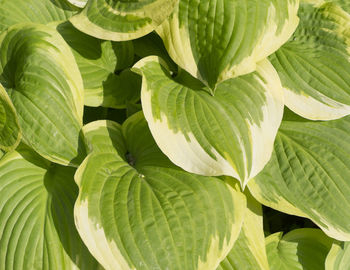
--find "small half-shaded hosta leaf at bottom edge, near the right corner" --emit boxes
[266,228,332,270]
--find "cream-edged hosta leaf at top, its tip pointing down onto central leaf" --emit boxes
[157,0,299,88]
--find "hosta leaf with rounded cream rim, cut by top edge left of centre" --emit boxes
[70,0,178,41]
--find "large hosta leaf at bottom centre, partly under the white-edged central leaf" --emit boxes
[75,113,245,270]
